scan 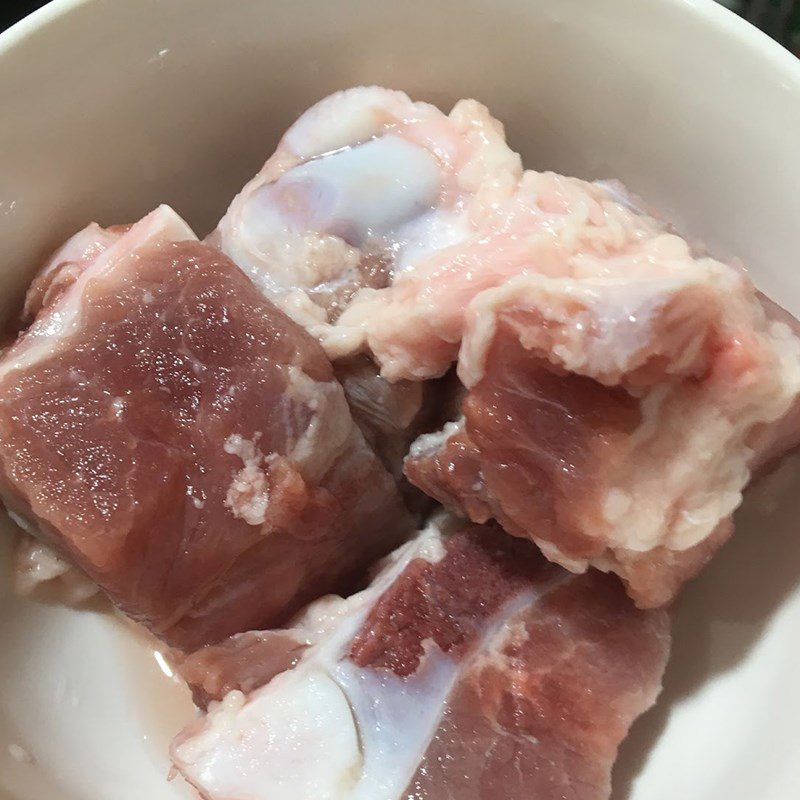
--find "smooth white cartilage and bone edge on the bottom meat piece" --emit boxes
[173,524,466,800]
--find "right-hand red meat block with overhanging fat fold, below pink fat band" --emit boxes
[406,264,800,607]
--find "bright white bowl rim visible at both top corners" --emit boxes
[0,0,800,88]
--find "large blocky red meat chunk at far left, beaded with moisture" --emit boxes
[0,207,411,650]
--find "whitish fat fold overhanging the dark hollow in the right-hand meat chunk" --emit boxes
[458,268,724,388]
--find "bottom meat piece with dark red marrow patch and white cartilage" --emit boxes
[172,526,669,800]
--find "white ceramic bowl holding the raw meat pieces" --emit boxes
[0,0,800,800]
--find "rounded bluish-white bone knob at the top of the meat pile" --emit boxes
[210,86,521,335]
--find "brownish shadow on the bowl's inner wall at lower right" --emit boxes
[612,456,800,800]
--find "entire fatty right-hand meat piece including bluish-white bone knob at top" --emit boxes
[213,87,800,606]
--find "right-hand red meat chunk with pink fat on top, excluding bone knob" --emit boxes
[320,153,800,606]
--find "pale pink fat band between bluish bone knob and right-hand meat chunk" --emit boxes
[325,171,708,380]
